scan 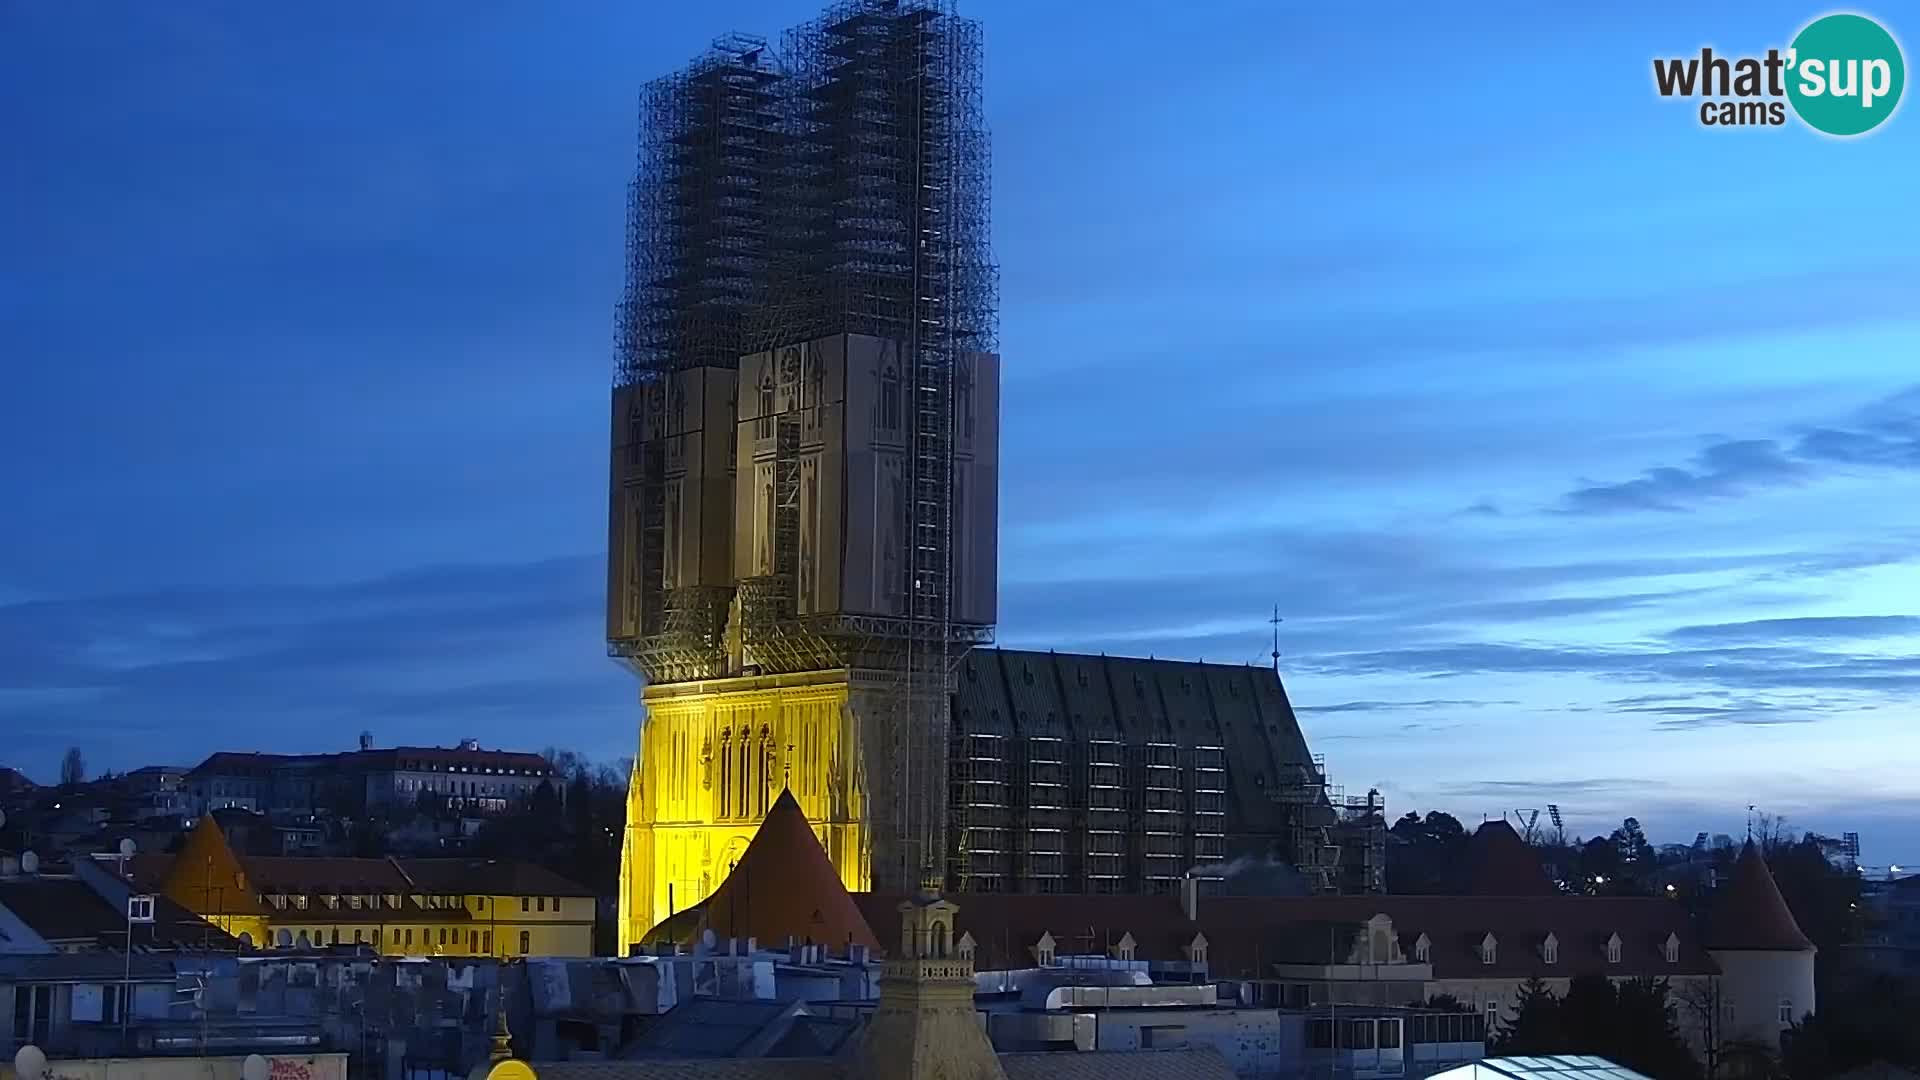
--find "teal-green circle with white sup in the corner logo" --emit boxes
[1788,13,1907,136]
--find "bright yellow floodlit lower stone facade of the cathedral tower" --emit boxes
[620,669,872,955]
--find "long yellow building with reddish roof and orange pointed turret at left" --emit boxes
[136,815,595,959]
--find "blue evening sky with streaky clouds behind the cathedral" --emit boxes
[0,0,1920,863]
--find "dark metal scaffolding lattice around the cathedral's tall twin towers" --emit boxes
[611,0,998,890]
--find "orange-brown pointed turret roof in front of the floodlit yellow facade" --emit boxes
[703,780,879,949]
